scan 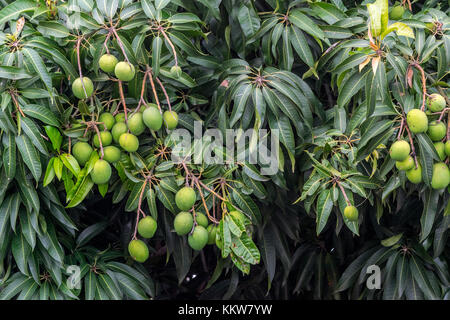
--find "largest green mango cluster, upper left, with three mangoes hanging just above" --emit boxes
[72,54,178,185]
